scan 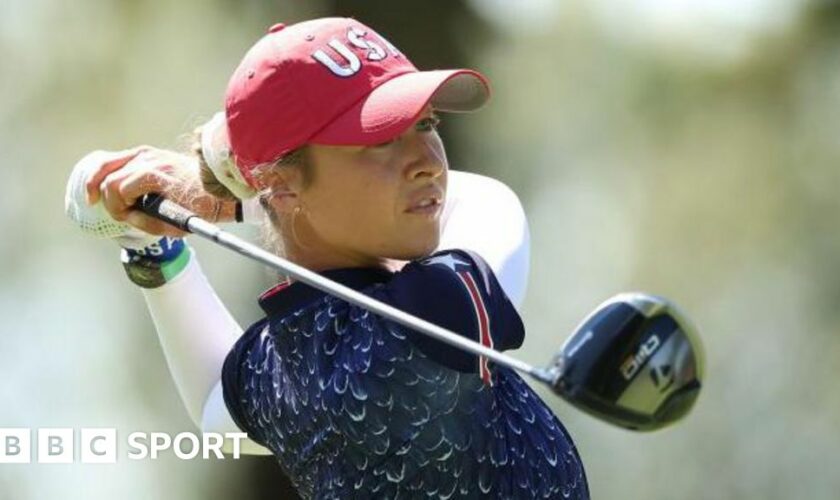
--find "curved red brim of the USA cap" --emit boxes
[307,69,490,146]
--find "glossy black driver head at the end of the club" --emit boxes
[548,293,704,431]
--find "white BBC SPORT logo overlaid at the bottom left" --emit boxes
[0,428,247,464]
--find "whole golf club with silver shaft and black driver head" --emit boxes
[135,194,703,430]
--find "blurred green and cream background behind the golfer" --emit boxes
[0,0,840,499]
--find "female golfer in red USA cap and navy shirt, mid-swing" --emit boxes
[67,18,589,499]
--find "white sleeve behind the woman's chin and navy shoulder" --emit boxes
[438,170,530,310]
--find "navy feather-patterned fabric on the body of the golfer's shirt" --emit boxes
[225,292,589,499]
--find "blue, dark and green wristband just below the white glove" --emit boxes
[120,237,192,288]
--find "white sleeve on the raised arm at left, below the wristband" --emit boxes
[143,249,269,454]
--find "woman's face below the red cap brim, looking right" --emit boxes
[296,109,448,266]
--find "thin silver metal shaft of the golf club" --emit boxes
[178,209,550,382]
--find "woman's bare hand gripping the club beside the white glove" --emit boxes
[85,146,236,237]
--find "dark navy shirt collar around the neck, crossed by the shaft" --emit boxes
[258,267,393,316]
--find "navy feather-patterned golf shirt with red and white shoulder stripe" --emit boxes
[222,250,589,499]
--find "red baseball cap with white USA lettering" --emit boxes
[225,18,490,186]
